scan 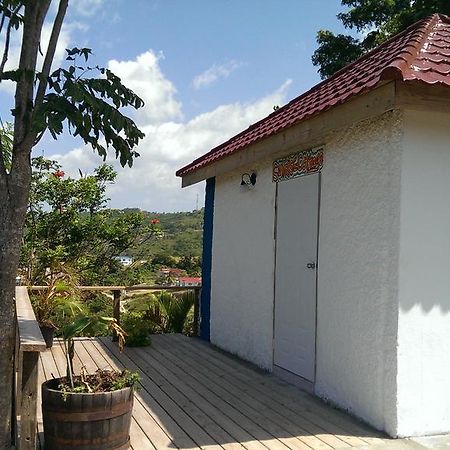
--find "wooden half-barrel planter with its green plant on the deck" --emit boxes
[42,316,139,450]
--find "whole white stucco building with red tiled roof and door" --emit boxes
[177,14,450,436]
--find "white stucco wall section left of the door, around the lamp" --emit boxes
[211,161,275,370]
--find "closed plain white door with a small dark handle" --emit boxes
[274,174,320,381]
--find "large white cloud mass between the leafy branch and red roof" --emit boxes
[50,52,291,211]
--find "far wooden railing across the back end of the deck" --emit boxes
[28,284,202,336]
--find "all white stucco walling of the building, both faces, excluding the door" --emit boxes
[211,105,450,436]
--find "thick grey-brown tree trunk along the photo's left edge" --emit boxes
[0,0,52,442]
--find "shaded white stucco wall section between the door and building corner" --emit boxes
[315,113,402,434]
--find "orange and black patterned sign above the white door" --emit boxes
[272,147,323,183]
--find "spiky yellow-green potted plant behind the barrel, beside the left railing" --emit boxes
[31,271,83,348]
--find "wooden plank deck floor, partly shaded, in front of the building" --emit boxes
[38,334,389,450]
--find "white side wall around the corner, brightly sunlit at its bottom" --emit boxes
[398,108,450,436]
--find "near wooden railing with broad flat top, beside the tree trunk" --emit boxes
[13,286,46,450]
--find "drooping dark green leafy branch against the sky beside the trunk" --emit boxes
[33,47,144,167]
